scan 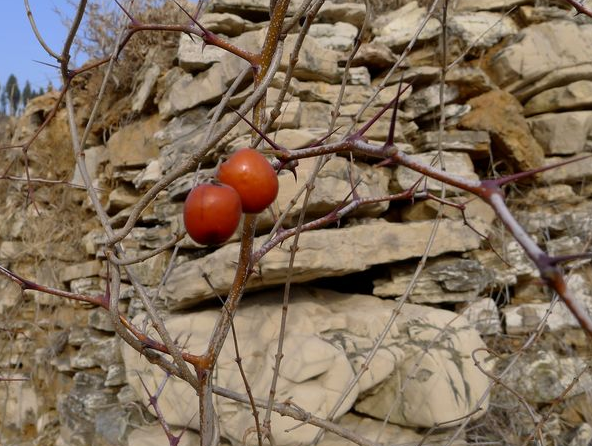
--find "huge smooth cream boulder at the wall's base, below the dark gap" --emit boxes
[123,288,488,445]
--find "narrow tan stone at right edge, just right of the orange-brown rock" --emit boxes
[524,80,592,116]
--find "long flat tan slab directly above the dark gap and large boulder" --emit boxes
[162,220,486,309]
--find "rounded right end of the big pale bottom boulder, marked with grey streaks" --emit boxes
[355,305,493,428]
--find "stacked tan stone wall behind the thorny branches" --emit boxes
[0,0,592,446]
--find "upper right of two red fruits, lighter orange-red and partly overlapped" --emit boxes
[218,148,279,214]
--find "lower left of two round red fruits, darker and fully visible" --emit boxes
[183,184,242,245]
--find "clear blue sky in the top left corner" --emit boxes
[0,0,80,90]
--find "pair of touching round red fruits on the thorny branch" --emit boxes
[183,148,279,245]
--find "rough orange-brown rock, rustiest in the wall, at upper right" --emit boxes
[460,90,544,170]
